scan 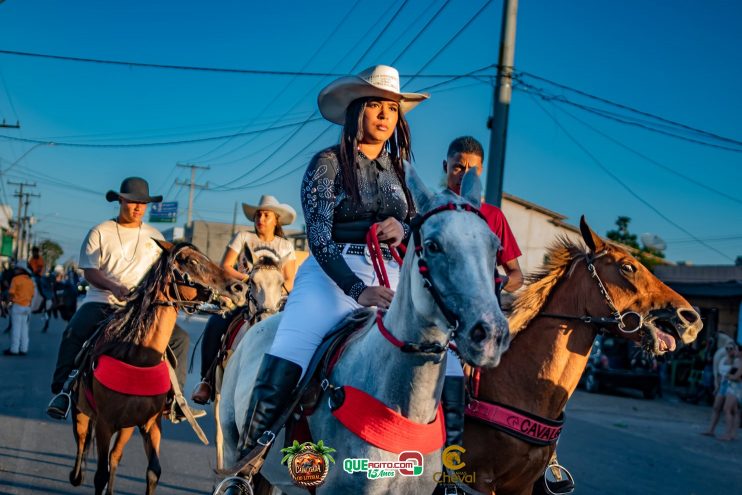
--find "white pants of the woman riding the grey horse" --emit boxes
[268,254,463,376]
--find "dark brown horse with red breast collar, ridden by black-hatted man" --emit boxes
[70,241,245,495]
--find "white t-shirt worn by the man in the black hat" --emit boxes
[80,220,165,306]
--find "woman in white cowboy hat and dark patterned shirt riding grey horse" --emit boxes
[234,65,454,457]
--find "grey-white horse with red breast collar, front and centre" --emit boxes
[215,166,509,495]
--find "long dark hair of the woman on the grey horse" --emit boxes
[338,97,415,219]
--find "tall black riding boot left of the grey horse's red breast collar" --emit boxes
[239,354,301,459]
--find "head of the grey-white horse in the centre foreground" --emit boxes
[406,165,509,367]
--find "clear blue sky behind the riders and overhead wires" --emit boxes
[0,0,742,264]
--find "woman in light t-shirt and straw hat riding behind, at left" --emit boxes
[191,195,296,404]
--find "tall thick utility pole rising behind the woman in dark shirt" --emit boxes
[485,0,518,206]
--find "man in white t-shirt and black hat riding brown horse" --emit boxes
[47,177,205,419]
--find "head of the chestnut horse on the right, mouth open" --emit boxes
[577,216,703,355]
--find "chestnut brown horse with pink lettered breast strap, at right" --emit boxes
[462,217,702,495]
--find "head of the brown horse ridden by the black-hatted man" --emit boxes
[155,240,247,310]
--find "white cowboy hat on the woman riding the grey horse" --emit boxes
[317,65,430,125]
